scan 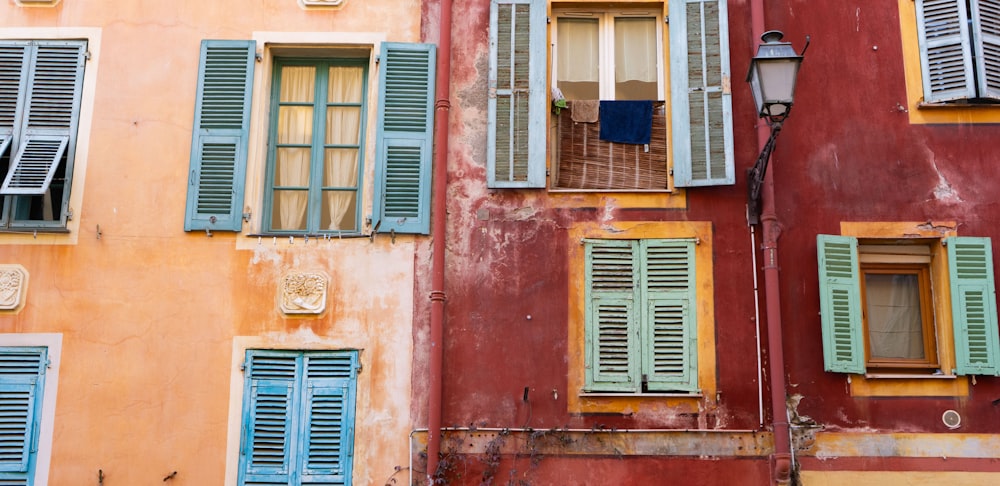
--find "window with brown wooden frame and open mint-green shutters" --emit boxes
[817,235,1000,376]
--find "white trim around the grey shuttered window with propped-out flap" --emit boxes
[0,27,101,245]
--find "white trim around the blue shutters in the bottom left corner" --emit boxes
[0,333,62,486]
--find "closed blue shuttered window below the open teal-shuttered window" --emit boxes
[239,350,359,486]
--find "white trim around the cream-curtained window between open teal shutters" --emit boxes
[236,32,386,250]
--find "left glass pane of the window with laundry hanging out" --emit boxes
[556,17,601,100]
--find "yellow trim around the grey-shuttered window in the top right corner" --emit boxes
[897,0,1000,124]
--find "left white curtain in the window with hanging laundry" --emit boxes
[556,18,600,82]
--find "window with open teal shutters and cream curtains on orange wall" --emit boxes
[185,40,435,235]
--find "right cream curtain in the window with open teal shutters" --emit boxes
[323,66,364,230]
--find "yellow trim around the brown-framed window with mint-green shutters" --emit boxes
[840,221,969,397]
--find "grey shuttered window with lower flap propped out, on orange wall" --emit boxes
[0,37,91,233]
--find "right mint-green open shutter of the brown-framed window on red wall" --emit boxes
[945,237,1000,376]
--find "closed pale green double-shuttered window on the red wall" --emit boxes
[584,239,699,393]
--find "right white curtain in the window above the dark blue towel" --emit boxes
[615,17,657,83]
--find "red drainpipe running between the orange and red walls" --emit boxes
[427,0,452,478]
